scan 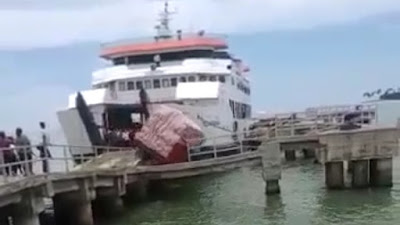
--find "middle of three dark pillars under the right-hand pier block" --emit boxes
[351,160,369,188]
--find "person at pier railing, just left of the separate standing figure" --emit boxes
[15,127,33,176]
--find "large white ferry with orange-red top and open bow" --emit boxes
[58,2,251,158]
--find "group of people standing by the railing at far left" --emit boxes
[0,122,51,176]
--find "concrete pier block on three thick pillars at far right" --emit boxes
[318,127,400,188]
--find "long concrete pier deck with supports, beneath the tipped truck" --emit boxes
[0,146,260,225]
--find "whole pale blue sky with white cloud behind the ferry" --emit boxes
[0,0,400,141]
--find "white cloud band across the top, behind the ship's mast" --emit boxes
[0,0,400,49]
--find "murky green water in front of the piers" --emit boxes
[110,161,400,225]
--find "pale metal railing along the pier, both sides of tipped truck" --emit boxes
[0,134,268,185]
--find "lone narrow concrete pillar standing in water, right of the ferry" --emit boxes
[259,141,282,195]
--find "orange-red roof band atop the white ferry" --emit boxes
[100,36,228,58]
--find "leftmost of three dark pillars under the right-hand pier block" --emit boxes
[325,162,344,189]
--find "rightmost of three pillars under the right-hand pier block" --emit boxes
[370,158,393,187]
